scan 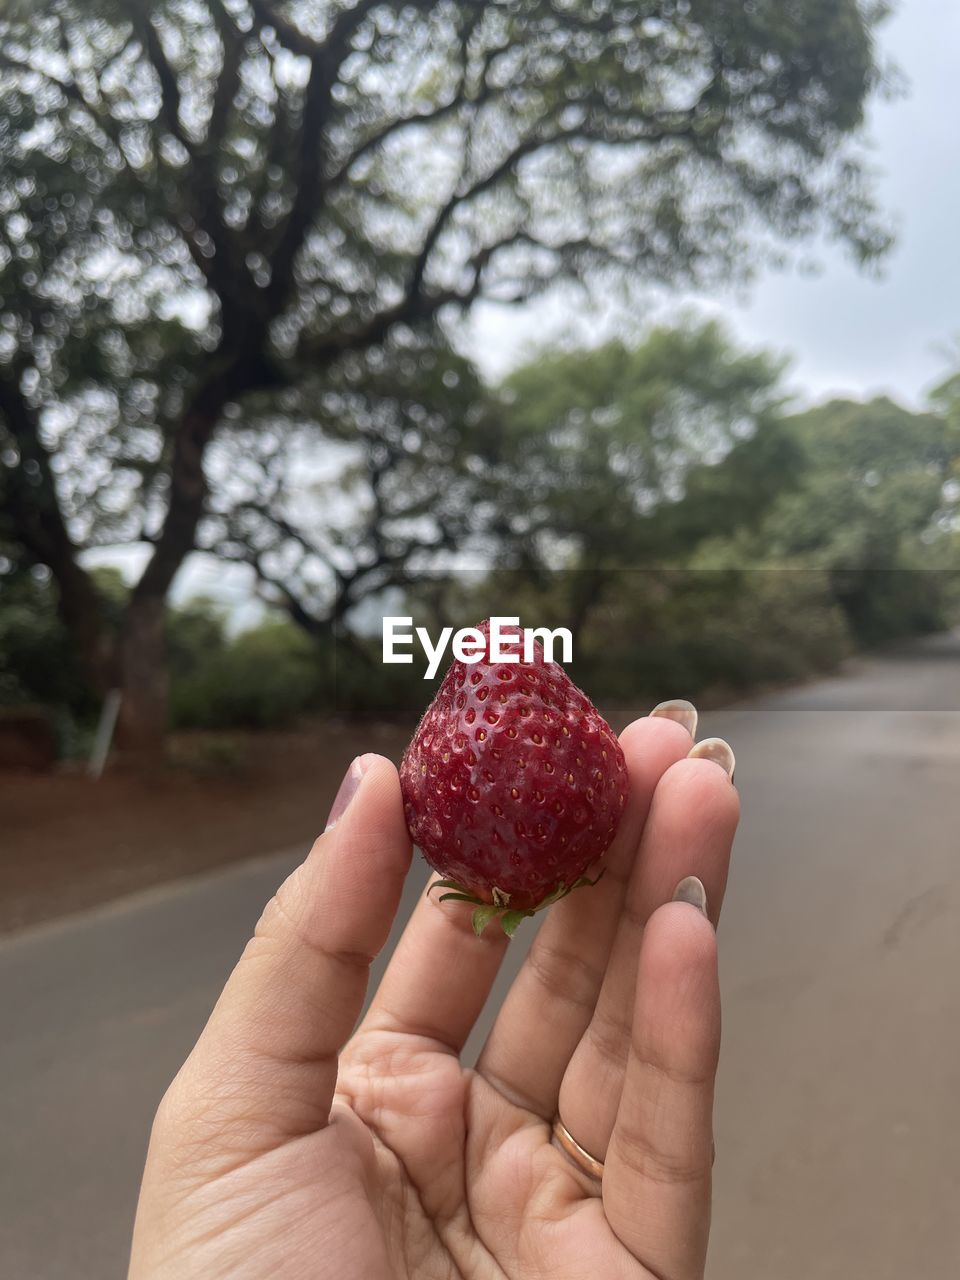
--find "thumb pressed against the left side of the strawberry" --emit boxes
[166,755,411,1153]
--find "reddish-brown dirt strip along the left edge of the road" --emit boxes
[0,723,412,933]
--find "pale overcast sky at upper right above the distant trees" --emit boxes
[471,0,960,406]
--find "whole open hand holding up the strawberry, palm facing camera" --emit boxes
[131,717,739,1280]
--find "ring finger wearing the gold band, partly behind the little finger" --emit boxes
[558,758,740,1160]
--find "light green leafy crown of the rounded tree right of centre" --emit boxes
[494,323,786,567]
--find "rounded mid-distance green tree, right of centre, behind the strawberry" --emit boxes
[489,321,796,637]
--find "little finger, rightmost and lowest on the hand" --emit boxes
[603,902,721,1280]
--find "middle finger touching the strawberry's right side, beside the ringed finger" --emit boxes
[476,716,691,1119]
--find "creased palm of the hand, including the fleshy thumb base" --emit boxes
[160,1032,649,1280]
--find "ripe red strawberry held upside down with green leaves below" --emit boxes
[399,622,627,937]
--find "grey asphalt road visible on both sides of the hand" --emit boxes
[0,637,960,1280]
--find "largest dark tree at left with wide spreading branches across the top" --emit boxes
[0,0,887,749]
